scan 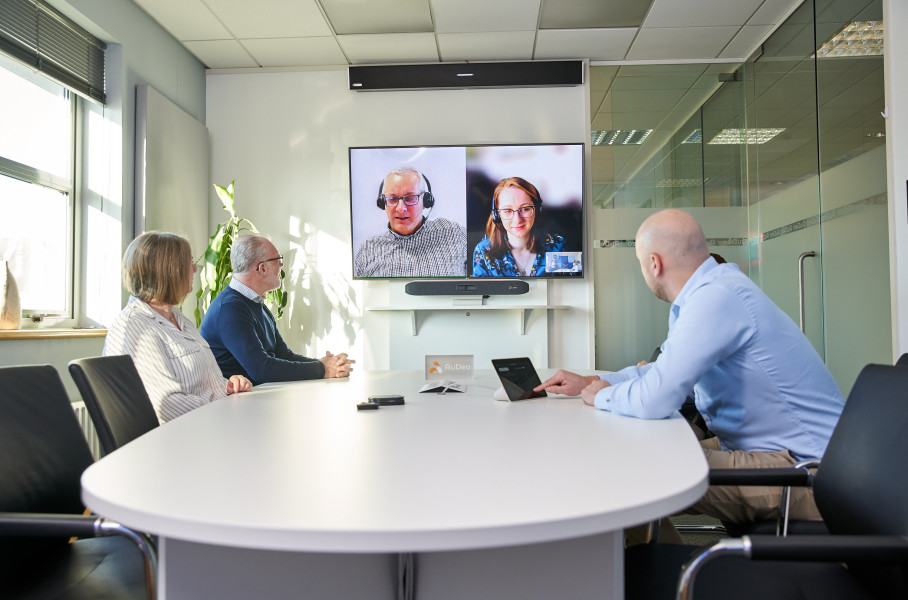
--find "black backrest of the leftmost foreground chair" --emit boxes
[0,365,93,569]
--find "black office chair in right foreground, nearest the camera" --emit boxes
[625,365,908,600]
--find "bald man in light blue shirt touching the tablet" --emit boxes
[537,209,845,523]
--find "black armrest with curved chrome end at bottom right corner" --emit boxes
[676,535,908,600]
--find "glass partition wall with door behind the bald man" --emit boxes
[590,0,892,394]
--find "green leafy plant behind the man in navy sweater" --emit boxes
[195,181,287,327]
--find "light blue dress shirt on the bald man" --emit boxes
[595,258,845,460]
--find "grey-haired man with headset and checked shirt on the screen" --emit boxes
[353,167,467,277]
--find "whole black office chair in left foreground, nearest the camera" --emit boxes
[0,365,157,600]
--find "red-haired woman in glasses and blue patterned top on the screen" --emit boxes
[473,177,564,277]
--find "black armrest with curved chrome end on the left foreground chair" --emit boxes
[0,512,158,600]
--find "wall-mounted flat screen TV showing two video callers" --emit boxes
[349,143,584,279]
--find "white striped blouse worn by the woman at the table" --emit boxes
[104,296,227,423]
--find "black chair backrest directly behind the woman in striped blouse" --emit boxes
[69,354,158,454]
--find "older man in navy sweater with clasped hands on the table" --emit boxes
[199,234,355,384]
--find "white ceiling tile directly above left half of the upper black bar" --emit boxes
[337,33,439,65]
